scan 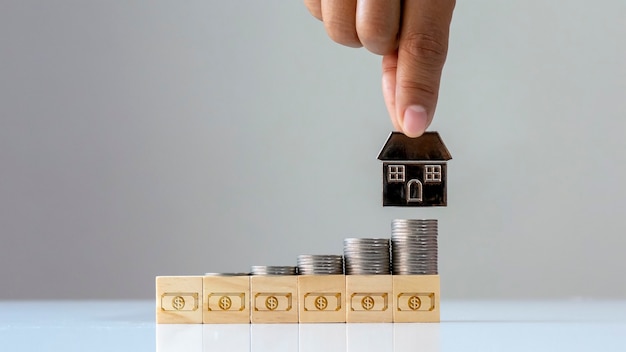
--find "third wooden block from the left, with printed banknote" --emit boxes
[250,275,298,323]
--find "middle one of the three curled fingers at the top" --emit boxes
[321,0,362,48]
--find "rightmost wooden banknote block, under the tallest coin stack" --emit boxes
[393,275,440,323]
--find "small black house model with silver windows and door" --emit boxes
[378,132,452,207]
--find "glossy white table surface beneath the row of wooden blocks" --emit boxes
[0,300,626,352]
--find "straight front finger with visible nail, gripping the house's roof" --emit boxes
[396,0,455,137]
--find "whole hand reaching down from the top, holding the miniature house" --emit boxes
[304,0,456,137]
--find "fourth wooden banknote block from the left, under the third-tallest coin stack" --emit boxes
[298,275,346,323]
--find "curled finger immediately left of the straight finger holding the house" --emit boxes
[356,0,401,55]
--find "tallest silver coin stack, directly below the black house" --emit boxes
[391,219,438,275]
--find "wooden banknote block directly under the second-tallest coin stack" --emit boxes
[346,275,393,323]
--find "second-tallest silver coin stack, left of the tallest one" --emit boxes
[343,238,391,275]
